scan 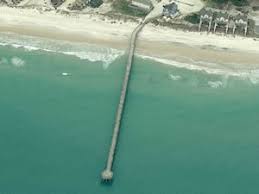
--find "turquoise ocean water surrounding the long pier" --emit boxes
[0,32,259,194]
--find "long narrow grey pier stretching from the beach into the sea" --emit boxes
[102,22,146,181]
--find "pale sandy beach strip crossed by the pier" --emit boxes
[0,7,259,70]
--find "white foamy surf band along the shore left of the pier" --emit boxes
[0,33,124,69]
